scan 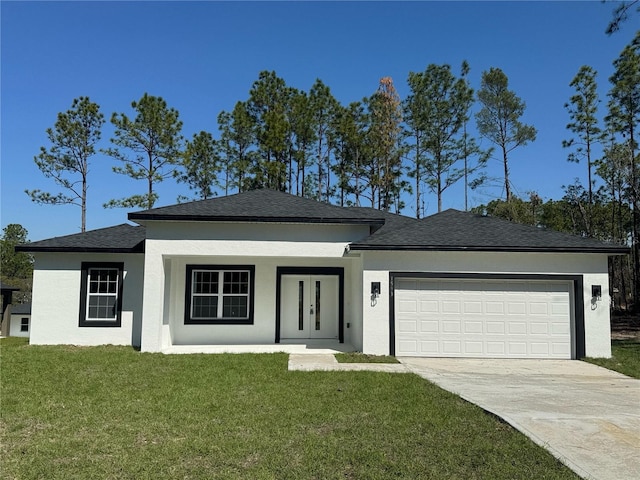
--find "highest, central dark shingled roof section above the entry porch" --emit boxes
[129,189,385,225]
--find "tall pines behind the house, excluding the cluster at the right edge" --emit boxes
[27,62,536,219]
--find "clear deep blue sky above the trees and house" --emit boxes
[0,1,638,240]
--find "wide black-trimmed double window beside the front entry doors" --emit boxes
[185,265,255,324]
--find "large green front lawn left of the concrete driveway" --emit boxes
[0,340,578,480]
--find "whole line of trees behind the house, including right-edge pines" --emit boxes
[27,32,640,312]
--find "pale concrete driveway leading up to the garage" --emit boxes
[400,357,640,480]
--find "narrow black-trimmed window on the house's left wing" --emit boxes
[80,262,124,327]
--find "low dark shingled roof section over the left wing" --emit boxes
[16,223,145,253]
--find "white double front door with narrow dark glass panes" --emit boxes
[280,275,339,339]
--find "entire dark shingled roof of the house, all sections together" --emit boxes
[16,190,629,254]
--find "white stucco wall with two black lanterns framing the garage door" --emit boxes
[362,251,611,357]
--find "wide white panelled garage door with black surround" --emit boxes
[394,278,572,358]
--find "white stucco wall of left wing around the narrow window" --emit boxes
[30,253,144,346]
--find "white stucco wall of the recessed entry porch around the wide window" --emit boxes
[142,222,369,351]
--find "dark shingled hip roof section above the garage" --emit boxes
[350,209,629,254]
